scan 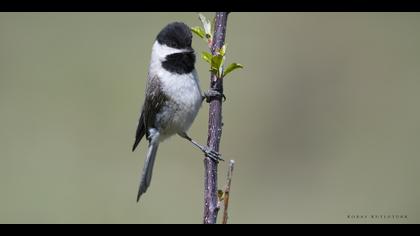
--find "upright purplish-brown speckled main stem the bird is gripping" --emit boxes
[203,12,228,224]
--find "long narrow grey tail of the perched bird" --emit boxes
[137,128,159,202]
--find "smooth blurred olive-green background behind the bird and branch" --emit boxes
[0,13,420,223]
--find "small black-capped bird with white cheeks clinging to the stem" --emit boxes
[133,22,222,202]
